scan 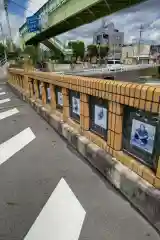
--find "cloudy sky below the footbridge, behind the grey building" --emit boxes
[59,0,160,44]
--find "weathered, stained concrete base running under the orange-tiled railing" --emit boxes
[9,84,160,232]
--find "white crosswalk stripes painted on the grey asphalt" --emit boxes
[0,83,86,240]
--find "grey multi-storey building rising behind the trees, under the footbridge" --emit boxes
[93,20,124,59]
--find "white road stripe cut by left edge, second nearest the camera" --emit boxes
[0,128,36,165]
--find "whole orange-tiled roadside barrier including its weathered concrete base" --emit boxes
[8,68,160,231]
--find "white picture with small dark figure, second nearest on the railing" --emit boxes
[94,105,107,129]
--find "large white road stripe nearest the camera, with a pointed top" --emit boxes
[24,178,86,240]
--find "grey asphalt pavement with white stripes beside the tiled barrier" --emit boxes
[0,81,160,240]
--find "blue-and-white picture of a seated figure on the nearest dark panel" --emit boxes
[130,119,156,154]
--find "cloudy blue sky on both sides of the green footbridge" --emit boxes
[0,0,160,44]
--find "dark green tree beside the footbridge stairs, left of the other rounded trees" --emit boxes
[68,41,85,61]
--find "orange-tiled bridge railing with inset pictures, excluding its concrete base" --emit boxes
[8,68,160,188]
